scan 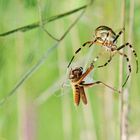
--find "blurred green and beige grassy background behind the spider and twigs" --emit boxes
[0,0,140,140]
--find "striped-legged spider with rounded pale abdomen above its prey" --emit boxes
[68,26,138,87]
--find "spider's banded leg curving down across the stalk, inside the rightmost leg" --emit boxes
[117,51,131,87]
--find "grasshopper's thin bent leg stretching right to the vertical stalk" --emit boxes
[80,81,121,93]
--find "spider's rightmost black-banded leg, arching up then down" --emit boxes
[117,43,138,73]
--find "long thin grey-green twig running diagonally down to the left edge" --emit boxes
[0,7,85,105]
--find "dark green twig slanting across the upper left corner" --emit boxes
[0,5,87,37]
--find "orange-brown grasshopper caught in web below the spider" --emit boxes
[69,63,121,106]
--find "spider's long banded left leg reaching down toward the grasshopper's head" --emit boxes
[67,40,96,68]
